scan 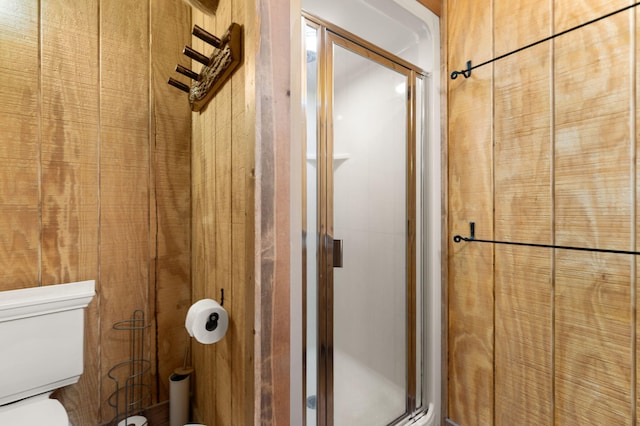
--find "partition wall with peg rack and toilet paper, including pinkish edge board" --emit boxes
[192,0,292,426]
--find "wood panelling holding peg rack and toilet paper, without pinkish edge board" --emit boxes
[191,1,255,425]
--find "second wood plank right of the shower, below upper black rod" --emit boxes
[494,42,553,425]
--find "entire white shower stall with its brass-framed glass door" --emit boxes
[302,0,441,426]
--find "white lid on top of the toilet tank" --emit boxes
[0,280,95,322]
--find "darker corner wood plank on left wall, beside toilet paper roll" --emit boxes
[151,1,191,401]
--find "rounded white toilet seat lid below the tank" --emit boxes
[0,399,69,426]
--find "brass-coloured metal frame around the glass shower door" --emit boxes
[302,12,428,426]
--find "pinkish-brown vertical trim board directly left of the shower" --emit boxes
[256,2,291,425]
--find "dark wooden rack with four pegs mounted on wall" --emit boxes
[167,23,242,111]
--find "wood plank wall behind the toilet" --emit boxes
[0,0,191,425]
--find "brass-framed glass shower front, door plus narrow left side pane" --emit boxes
[303,17,423,426]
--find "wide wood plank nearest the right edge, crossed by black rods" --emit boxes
[554,8,633,424]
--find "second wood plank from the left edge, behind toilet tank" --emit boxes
[41,1,100,424]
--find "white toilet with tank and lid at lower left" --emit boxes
[0,280,95,426]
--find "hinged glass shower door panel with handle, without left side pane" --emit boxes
[324,35,415,426]
